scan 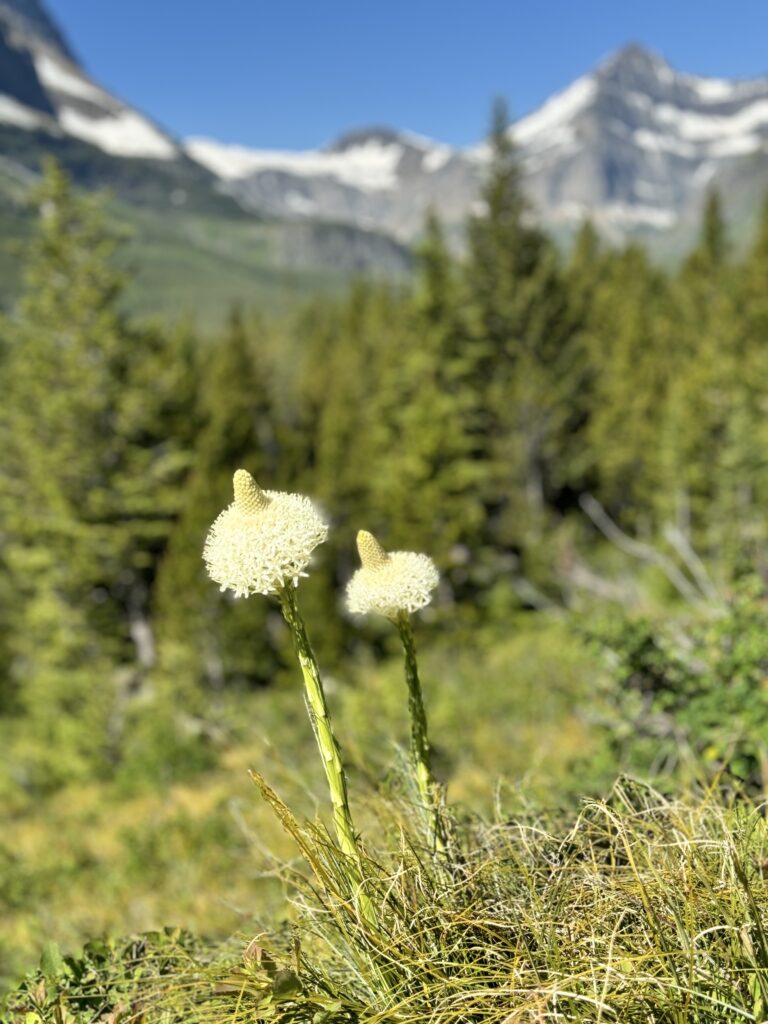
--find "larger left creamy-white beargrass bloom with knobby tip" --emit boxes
[203,469,328,597]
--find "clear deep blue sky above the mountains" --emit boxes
[47,0,768,148]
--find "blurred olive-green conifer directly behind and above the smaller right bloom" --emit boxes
[369,213,482,569]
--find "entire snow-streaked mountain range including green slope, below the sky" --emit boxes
[0,0,768,312]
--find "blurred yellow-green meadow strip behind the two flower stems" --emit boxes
[0,626,597,979]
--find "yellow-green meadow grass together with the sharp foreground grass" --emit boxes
[9,615,768,1024]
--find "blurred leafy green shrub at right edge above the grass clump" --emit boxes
[589,579,768,794]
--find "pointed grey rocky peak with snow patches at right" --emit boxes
[515,46,768,234]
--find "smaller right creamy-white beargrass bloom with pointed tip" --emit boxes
[347,529,439,618]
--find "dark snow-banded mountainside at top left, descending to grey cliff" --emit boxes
[0,0,411,274]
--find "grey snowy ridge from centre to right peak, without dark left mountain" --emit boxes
[183,43,768,243]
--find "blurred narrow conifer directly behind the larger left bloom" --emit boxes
[155,310,279,696]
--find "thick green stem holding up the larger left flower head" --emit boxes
[280,584,362,864]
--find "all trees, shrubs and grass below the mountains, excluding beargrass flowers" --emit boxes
[0,101,768,1024]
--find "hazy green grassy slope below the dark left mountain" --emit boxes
[0,148,385,330]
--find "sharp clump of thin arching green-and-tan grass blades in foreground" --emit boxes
[105,778,768,1024]
